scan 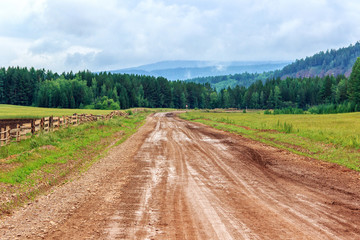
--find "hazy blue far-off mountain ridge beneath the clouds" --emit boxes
[110,61,290,80]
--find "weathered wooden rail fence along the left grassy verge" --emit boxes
[0,109,134,146]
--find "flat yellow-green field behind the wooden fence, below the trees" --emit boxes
[0,104,116,119]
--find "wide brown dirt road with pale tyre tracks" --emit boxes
[0,113,360,239]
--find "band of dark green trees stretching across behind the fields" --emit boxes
[0,58,360,112]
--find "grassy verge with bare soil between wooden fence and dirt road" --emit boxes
[0,112,150,217]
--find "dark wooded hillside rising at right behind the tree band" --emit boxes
[187,42,360,90]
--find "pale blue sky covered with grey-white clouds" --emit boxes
[0,0,360,73]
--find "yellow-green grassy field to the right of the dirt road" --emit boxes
[180,111,360,171]
